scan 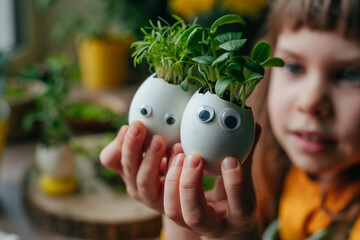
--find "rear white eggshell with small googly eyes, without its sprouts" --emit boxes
[129,74,193,148]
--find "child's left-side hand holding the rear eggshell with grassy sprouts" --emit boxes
[100,121,182,213]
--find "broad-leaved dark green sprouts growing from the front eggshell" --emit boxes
[177,14,284,108]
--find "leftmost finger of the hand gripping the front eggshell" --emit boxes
[164,154,185,226]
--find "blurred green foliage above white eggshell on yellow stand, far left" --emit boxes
[23,57,69,146]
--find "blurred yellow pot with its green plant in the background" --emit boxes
[37,0,163,90]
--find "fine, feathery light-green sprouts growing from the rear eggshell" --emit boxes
[131,15,190,85]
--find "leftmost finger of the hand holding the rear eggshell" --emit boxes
[100,125,129,175]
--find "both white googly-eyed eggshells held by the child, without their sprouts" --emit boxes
[129,74,255,175]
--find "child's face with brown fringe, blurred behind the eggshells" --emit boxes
[268,28,360,174]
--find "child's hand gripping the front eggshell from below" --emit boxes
[164,126,260,239]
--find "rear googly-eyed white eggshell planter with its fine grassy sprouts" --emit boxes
[129,16,197,148]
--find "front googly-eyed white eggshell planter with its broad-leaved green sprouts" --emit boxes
[180,14,283,175]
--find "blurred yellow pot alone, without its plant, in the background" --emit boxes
[78,38,131,90]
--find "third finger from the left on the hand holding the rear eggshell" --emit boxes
[136,135,166,206]
